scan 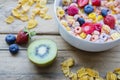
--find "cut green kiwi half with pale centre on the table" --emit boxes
[27,39,57,67]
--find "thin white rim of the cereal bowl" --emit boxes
[54,0,120,45]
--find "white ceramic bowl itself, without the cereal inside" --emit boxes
[54,0,120,52]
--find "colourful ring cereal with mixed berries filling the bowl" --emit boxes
[57,0,120,43]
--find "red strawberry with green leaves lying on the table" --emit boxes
[16,28,36,45]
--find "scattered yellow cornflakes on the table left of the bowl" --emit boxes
[5,0,52,29]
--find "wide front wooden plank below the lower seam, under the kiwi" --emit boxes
[0,50,120,80]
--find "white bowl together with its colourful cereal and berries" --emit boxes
[54,0,120,52]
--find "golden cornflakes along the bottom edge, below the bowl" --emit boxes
[61,58,120,80]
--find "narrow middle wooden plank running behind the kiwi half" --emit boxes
[0,34,120,52]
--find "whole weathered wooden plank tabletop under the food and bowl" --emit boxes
[0,0,120,80]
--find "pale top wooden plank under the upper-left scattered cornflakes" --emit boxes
[0,0,59,34]
